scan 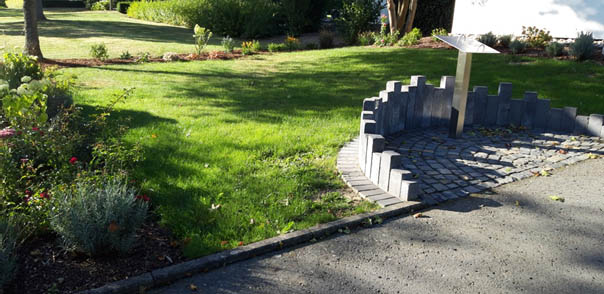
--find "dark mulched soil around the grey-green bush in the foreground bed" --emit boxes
[6,221,186,294]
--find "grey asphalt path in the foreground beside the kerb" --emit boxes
[150,159,604,294]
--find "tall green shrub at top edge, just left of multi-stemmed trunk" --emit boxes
[336,0,382,44]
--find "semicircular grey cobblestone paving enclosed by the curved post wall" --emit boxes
[386,128,604,203]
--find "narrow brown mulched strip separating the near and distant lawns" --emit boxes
[41,51,248,67]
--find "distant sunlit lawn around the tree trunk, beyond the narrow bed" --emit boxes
[0,5,231,59]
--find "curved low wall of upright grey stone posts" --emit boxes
[357,76,604,201]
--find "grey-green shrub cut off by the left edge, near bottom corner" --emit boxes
[0,216,17,293]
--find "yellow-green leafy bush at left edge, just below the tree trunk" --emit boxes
[0,53,44,89]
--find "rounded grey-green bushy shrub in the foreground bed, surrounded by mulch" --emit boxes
[50,178,148,256]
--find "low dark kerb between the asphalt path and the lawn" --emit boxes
[78,192,431,294]
